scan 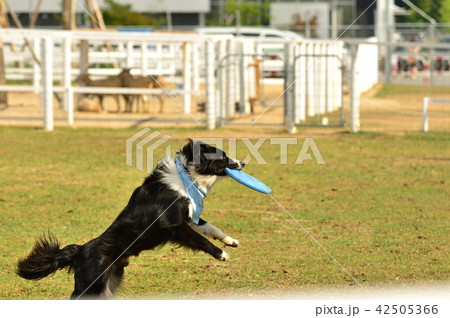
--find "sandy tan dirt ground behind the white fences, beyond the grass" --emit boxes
[0,84,450,135]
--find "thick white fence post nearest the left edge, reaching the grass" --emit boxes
[41,36,53,131]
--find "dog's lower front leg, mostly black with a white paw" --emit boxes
[167,223,230,261]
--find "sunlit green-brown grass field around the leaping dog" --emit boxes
[0,127,450,299]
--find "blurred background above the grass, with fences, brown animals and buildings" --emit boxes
[0,0,450,131]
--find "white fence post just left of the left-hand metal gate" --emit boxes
[205,40,216,129]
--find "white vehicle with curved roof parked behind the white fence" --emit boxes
[195,27,303,77]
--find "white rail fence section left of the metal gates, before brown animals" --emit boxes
[0,29,215,130]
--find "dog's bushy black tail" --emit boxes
[16,235,82,280]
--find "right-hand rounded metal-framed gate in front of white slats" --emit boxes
[284,44,345,131]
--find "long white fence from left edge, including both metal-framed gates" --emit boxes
[0,29,344,130]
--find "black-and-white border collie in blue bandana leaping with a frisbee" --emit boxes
[16,139,244,299]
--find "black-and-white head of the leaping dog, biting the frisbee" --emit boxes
[179,139,245,177]
